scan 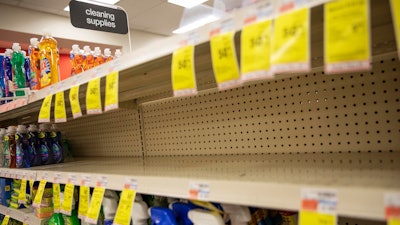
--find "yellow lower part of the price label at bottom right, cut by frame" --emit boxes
[299,210,337,225]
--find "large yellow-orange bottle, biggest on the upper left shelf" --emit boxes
[39,32,60,88]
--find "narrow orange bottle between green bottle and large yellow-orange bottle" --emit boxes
[28,38,40,90]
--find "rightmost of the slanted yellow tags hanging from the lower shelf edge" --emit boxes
[113,189,136,225]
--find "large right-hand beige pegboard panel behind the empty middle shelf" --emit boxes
[141,53,400,156]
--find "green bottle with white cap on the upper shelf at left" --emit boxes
[11,43,26,96]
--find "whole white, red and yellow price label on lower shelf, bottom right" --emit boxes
[299,189,338,225]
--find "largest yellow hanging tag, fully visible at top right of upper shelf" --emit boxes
[324,0,371,73]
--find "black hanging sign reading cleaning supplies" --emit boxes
[69,1,128,34]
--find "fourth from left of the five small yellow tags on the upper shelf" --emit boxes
[86,78,102,114]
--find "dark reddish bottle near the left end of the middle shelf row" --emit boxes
[4,126,17,168]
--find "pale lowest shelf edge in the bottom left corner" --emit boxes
[0,205,49,225]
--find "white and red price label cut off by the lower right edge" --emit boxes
[384,193,400,225]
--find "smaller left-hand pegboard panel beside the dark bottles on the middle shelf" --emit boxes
[58,104,143,157]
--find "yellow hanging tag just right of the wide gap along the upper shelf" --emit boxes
[171,45,197,96]
